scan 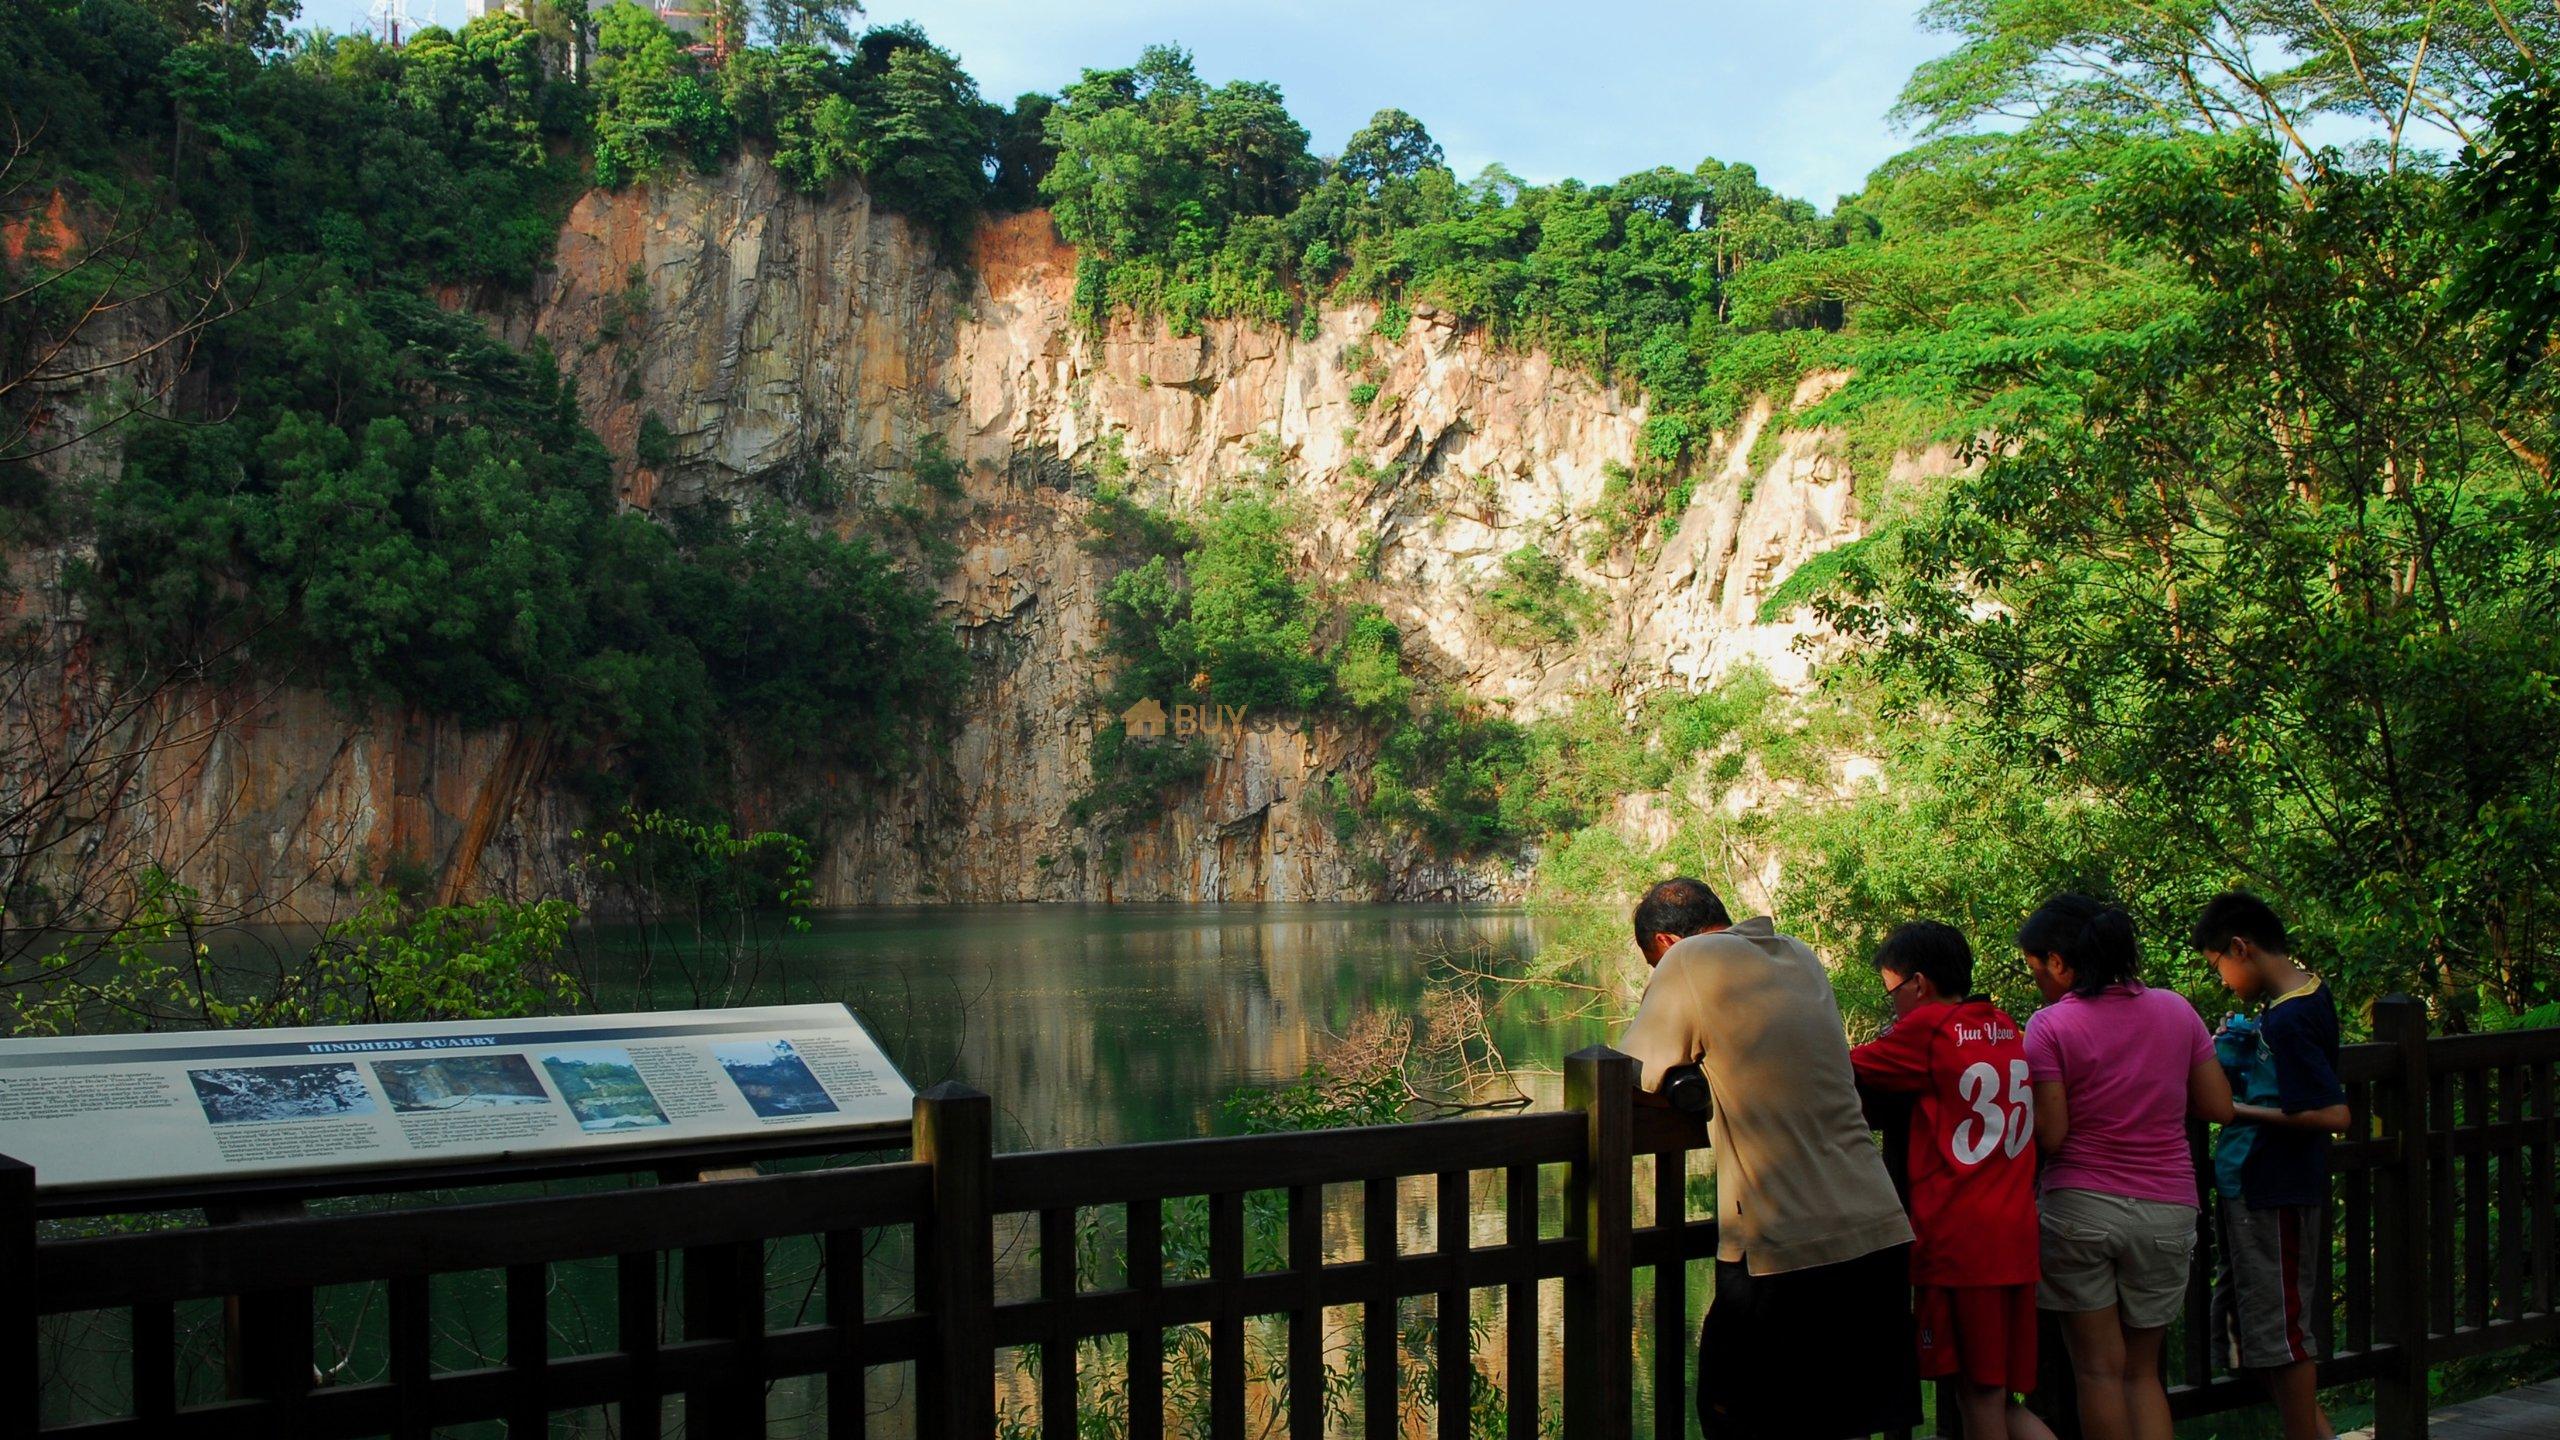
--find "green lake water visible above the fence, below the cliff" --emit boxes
[594,904,1608,1150]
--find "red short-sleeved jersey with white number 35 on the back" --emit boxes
[1848,999,2038,1286]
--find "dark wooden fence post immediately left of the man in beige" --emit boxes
[1564,1045,1644,1435]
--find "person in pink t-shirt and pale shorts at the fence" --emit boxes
[2017,894,2232,1440]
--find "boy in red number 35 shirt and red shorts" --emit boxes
[1848,920,2053,1440]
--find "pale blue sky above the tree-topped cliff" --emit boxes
[285,0,1948,210]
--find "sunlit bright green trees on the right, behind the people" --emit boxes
[1769,3,2560,1022]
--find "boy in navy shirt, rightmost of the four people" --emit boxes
[2191,892,2350,1440]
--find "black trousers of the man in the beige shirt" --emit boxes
[1697,1245,1920,1440]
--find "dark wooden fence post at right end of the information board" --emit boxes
[916,1081,996,1440]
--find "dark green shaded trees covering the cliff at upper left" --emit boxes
[0,0,962,810]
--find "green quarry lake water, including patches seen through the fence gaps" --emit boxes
[46,904,1705,1437]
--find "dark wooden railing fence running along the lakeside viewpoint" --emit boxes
[0,999,2560,1440]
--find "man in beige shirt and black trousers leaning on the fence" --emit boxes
[1618,879,1920,1440]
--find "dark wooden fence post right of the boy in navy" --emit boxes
[2373,994,2432,1440]
